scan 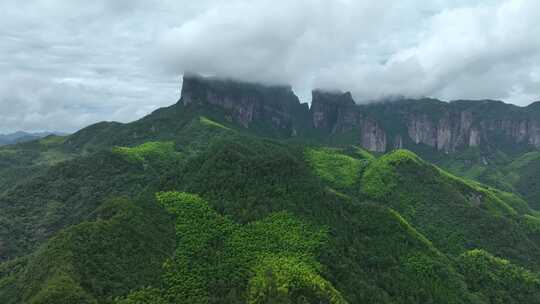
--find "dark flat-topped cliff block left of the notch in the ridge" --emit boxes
[181,75,308,135]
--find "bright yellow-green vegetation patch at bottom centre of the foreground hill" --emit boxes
[120,192,340,303]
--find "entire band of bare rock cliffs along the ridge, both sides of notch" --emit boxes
[181,76,540,153]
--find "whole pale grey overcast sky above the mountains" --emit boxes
[0,0,540,133]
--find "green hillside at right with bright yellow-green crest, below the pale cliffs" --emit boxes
[362,150,540,269]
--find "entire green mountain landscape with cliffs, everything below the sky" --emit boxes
[0,76,540,304]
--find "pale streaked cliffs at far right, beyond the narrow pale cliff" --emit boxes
[402,100,540,152]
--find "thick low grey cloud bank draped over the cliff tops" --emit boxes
[159,0,540,104]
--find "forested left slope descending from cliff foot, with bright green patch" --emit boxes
[0,116,234,260]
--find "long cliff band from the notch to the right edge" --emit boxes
[312,98,540,153]
